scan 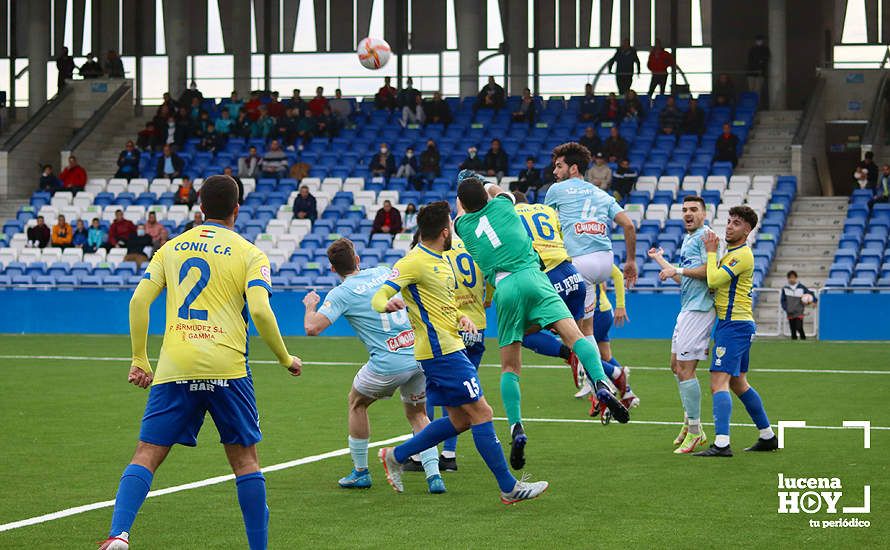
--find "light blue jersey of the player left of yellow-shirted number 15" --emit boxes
[318,267,417,375]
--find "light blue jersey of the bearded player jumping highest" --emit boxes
[544,178,624,256]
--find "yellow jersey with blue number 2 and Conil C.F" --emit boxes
[139,223,272,384]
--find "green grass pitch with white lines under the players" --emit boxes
[0,335,890,549]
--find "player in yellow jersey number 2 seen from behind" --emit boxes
[100,176,302,550]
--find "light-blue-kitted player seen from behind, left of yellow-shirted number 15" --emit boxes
[303,239,445,494]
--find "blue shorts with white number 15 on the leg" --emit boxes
[418,350,482,407]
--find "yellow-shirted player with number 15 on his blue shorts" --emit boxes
[371,201,548,504]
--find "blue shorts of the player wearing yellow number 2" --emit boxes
[139,376,263,447]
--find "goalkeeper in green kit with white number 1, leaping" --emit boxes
[454,170,630,470]
